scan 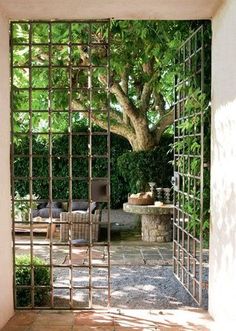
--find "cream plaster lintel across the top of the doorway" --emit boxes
[0,0,224,20]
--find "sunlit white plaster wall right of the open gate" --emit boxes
[209,0,236,330]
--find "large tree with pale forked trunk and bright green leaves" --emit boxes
[13,21,191,151]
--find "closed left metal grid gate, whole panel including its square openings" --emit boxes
[10,20,110,309]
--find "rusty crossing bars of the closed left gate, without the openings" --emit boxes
[10,20,111,309]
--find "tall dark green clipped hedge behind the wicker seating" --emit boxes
[14,125,131,208]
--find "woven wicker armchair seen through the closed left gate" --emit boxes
[60,209,101,242]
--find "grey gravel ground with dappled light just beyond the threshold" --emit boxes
[55,266,208,309]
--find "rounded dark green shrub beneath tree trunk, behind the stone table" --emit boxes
[118,135,173,193]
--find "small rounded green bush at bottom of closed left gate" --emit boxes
[15,255,50,307]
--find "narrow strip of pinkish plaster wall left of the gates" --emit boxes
[0,12,13,329]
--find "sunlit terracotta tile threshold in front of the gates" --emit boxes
[2,309,216,331]
